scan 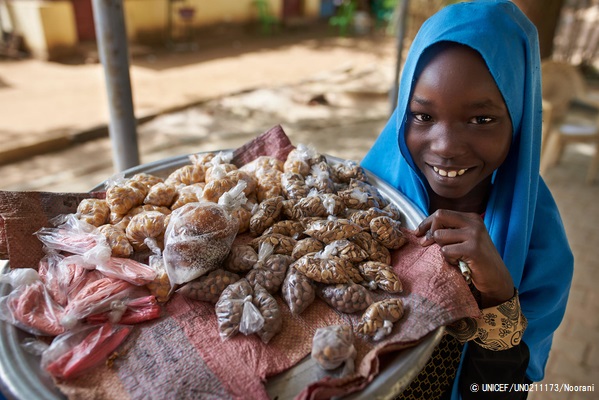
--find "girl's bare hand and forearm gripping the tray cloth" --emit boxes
[415,210,514,308]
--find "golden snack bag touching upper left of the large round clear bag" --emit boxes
[125,211,166,251]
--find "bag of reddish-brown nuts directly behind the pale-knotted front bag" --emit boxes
[246,243,293,293]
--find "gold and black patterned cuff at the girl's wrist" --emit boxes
[447,292,527,351]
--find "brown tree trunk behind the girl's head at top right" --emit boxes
[513,0,564,59]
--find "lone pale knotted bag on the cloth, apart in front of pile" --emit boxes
[312,325,357,376]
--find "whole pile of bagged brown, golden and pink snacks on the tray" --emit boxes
[1,145,407,379]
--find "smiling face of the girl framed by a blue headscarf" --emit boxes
[406,45,512,212]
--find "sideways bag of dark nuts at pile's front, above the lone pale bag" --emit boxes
[316,283,372,314]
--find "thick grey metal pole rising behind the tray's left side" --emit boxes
[93,0,139,172]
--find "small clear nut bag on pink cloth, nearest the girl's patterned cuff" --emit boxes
[357,298,404,341]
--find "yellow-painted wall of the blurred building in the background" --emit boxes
[2,0,320,60]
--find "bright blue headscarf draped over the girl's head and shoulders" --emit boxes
[362,0,573,390]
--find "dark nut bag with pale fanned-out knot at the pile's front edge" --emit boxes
[215,278,264,341]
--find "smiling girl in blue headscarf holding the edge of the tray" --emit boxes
[362,0,573,399]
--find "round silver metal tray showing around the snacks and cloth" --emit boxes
[0,155,444,400]
